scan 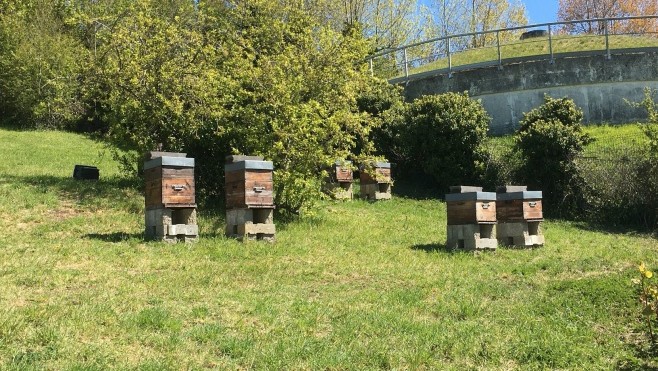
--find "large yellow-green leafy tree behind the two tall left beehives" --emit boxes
[80,0,376,213]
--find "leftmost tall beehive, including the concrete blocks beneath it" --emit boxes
[144,152,199,242]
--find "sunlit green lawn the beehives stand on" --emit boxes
[0,129,658,370]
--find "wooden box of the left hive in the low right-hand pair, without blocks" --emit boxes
[445,192,496,225]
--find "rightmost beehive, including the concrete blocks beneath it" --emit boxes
[496,186,544,247]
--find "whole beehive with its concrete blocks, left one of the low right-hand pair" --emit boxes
[445,186,498,250]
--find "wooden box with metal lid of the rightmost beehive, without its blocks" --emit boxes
[496,191,544,222]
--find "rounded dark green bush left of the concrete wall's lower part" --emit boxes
[380,93,489,190]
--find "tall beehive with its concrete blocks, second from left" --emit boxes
[224,155,276,241]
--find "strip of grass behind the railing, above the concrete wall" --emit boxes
[386,35,658,77]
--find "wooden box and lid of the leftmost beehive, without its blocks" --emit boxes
[144,156,196,208]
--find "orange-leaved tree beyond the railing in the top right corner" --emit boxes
[558,0,658,35]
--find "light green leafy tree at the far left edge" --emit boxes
[0,0,86,128]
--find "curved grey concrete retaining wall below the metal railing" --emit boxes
[401,48,658,134]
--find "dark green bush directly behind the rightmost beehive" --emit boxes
[515,96,591,215]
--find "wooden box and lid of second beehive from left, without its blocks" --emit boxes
[224,158,274,210]
